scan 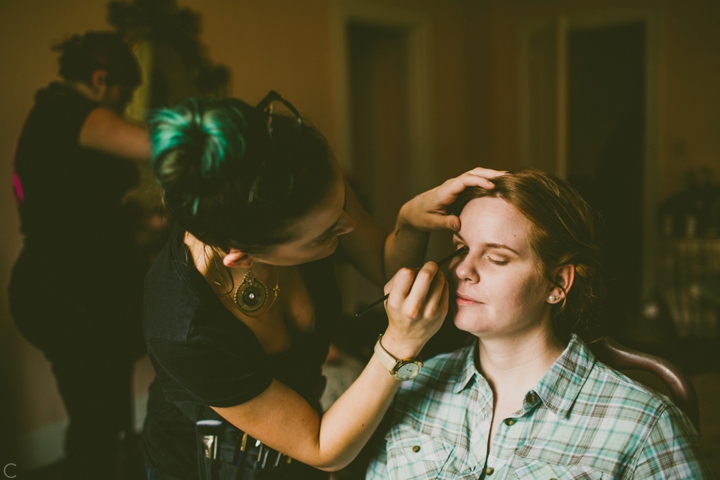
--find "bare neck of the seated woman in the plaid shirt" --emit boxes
[478,322,565,389]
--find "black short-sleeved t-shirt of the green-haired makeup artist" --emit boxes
[143,228,340,480]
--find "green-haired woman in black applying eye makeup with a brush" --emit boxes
[143,92,498,480]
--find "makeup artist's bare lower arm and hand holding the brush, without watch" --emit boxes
[215,262,448,470]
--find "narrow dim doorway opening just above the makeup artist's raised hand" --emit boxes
[347,22,412,231]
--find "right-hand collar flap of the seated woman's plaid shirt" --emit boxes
[535,334,595,417]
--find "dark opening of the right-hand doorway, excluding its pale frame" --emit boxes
[566,22,647,337]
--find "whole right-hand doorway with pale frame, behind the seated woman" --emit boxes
[518,12,661,338]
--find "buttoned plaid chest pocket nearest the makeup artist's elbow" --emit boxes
[385,424,475,480]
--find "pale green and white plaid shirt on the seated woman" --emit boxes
[366,336,711,480]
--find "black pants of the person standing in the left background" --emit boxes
[9,249,142,480]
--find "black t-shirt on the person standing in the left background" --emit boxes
[15,83,140,248]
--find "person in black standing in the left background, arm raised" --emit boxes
[9,32,150,480]
